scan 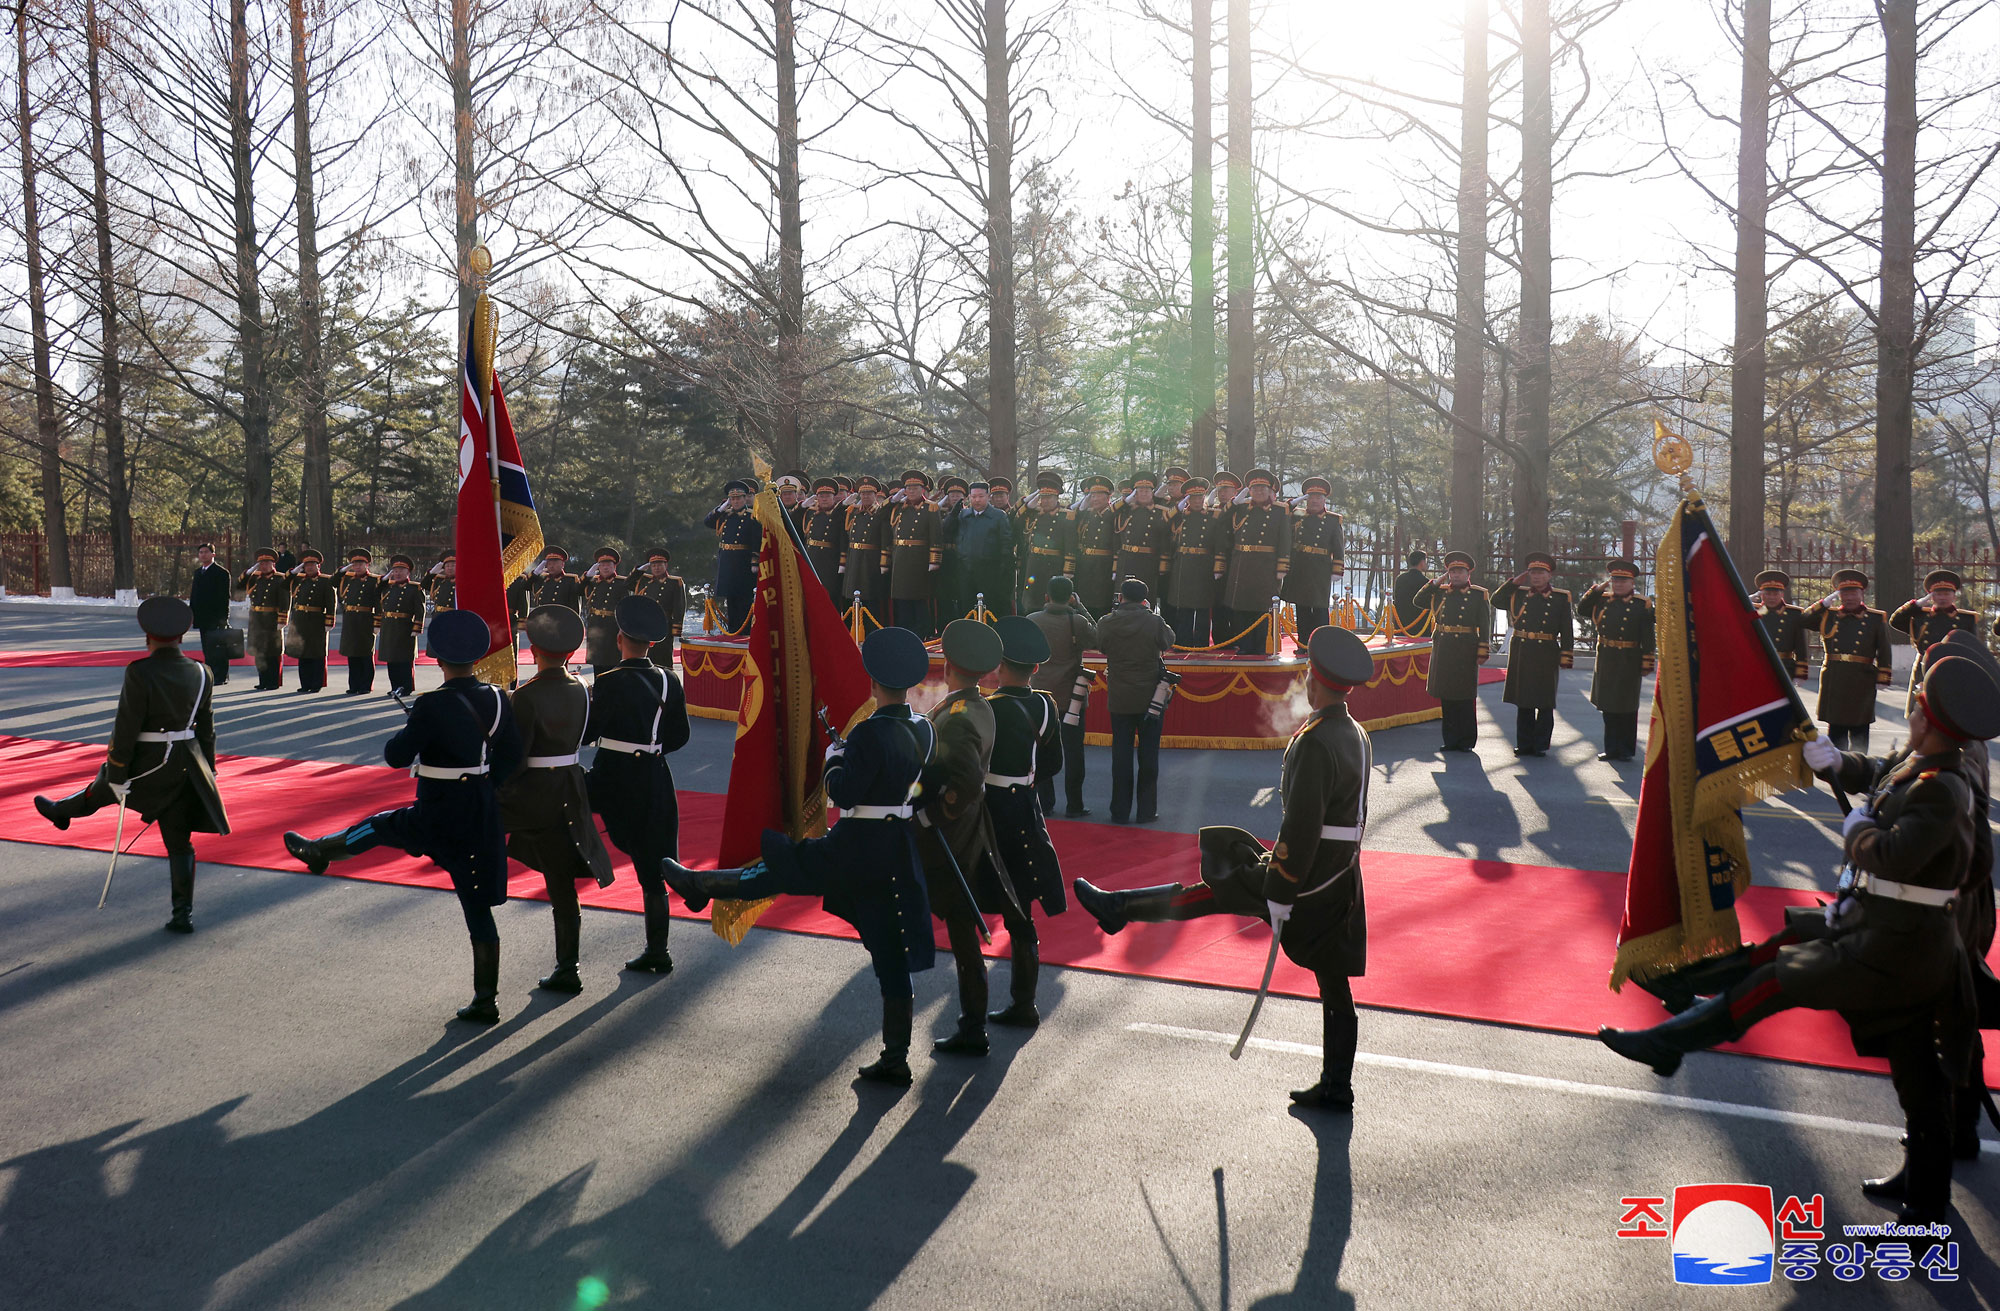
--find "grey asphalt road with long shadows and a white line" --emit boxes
[0,606,2000,1311]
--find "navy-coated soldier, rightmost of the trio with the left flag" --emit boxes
[584,596,698,973]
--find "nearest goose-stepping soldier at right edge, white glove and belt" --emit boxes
[1598,656,2000,1225]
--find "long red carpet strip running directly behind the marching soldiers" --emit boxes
[0,737,2000,1085]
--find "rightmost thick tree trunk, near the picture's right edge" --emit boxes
[1874,0,1916,606]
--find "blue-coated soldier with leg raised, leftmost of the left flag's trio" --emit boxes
[284,610,520,1025]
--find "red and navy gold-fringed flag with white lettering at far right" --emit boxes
[1610,494,1816,991]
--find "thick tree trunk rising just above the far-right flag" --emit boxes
[1730,0,1770,578]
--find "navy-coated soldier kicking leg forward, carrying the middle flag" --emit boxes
[678,628,936,1087]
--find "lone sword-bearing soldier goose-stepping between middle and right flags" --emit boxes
[1072,628,1374,1113]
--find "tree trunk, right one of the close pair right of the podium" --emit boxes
[1514,0,1554,568]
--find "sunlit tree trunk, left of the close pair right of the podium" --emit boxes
[1450,0,1490,560]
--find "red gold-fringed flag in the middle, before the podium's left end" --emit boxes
[710,462,874,943]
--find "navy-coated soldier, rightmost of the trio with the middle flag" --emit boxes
[986,616,1070,1029]
